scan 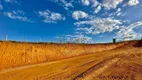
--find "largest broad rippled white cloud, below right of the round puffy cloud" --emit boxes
[75,18,122,34]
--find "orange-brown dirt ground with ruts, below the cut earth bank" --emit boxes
[0,41,142,80]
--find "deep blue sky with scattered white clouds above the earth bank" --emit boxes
[0,0,142,43]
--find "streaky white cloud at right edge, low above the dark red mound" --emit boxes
[117,22,142,40]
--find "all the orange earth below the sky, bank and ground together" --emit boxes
[0,40,142,80]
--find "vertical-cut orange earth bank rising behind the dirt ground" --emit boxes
[0,41,129,70]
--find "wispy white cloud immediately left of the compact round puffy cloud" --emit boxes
[38,10,65,23]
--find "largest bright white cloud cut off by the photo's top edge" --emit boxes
[102,0,123,10]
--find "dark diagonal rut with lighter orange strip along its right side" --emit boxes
[73,57,120,80]
